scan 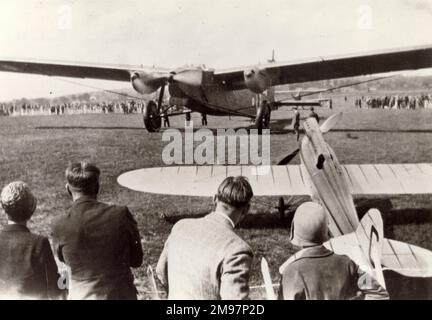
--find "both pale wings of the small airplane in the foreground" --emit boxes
[117,163,432,196]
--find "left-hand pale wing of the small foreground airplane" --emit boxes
[117,166,309,197]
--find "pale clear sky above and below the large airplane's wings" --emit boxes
[0,0,432,101]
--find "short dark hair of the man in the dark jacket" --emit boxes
[65,161,100,194]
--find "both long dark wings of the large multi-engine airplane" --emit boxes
[0,45,432,89]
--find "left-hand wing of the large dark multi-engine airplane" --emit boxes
[0,59,168,81]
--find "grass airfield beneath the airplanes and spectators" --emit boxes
[0,99,432,299]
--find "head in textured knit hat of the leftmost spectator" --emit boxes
[0,181,37,222]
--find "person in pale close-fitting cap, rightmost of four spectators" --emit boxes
[279,202,388,300]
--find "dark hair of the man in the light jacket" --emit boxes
[216,176,253,209]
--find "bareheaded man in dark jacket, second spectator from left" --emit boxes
[52,162,143,300]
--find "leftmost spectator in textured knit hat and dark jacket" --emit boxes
[0,181,62,299]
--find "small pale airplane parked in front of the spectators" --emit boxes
[117,113,432,284]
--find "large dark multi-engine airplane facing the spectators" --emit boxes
[0,45,432,132]
